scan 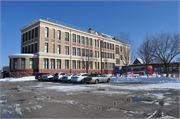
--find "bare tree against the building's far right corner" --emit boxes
[119,32,136,77]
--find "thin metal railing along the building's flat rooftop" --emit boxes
[44,18,88,32]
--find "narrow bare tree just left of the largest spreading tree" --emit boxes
[137,35,154,76]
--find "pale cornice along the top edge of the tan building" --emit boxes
[20,19,131,47]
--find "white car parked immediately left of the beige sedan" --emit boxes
[71,73,89,83]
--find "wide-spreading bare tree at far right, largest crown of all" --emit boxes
[151,32,180,74]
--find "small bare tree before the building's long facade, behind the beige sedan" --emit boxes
[81,49,96,73]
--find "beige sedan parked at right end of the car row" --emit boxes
[84,74,111,84]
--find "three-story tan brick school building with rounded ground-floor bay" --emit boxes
[9,19,130,74]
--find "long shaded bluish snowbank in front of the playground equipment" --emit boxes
[110,77,180,83]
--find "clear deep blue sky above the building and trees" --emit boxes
[0,1,179,69]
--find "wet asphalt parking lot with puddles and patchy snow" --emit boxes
[0,81,179,118]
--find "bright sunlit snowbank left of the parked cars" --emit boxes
[0,76,36,81]
